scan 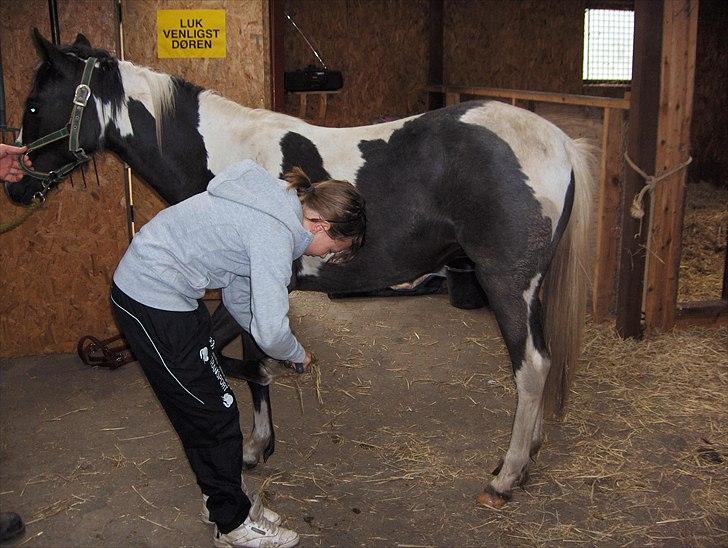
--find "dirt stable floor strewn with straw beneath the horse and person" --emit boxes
[0,293,728,547]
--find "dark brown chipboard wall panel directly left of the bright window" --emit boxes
[443,0,584,93]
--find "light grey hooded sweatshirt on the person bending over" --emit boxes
[114,160,313,362]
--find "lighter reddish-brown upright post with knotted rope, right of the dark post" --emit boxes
[644,0,698,336]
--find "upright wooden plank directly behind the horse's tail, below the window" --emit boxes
[592,108,625,322]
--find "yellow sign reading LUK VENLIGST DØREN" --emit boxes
[157,10,226,58]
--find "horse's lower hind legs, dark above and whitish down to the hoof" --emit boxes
[478,274,550,507]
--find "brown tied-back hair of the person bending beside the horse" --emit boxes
[283,166,367,263]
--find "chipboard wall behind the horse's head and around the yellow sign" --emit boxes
[0,0,270,357]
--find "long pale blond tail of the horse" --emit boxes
[543,139,596,416]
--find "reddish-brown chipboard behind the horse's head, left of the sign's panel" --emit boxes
[0,0,126,356]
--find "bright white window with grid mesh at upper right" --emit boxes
[584,9,634,81]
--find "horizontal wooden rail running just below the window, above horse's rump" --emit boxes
[427,85,629,110]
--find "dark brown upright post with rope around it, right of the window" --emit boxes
[617,0,663,338]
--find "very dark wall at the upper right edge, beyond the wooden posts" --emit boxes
[690,0,728,187]
